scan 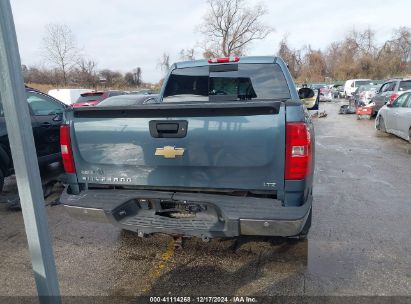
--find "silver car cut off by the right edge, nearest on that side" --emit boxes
[375,90,411,143]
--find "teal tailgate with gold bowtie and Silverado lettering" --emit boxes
[67,101,285,190]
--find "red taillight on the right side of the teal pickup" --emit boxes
[285,122,312,180]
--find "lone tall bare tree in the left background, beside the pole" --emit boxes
[43,23,78,85]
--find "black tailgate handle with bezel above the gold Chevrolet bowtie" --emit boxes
[149,120,188,138]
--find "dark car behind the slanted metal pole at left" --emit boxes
[0,87,67,192]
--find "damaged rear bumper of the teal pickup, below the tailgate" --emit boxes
[61,189,312,238]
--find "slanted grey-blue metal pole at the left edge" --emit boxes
[0,0,61,303]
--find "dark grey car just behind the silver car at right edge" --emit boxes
[372,78,411,111]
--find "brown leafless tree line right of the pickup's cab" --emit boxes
[277,27,411,83]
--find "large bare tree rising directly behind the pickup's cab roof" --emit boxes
[200,0,273,57]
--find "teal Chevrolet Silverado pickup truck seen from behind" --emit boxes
[60,57,314,241]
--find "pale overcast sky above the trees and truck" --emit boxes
[11,0,411,82]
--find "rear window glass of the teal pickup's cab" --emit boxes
[163,64,290,102]
